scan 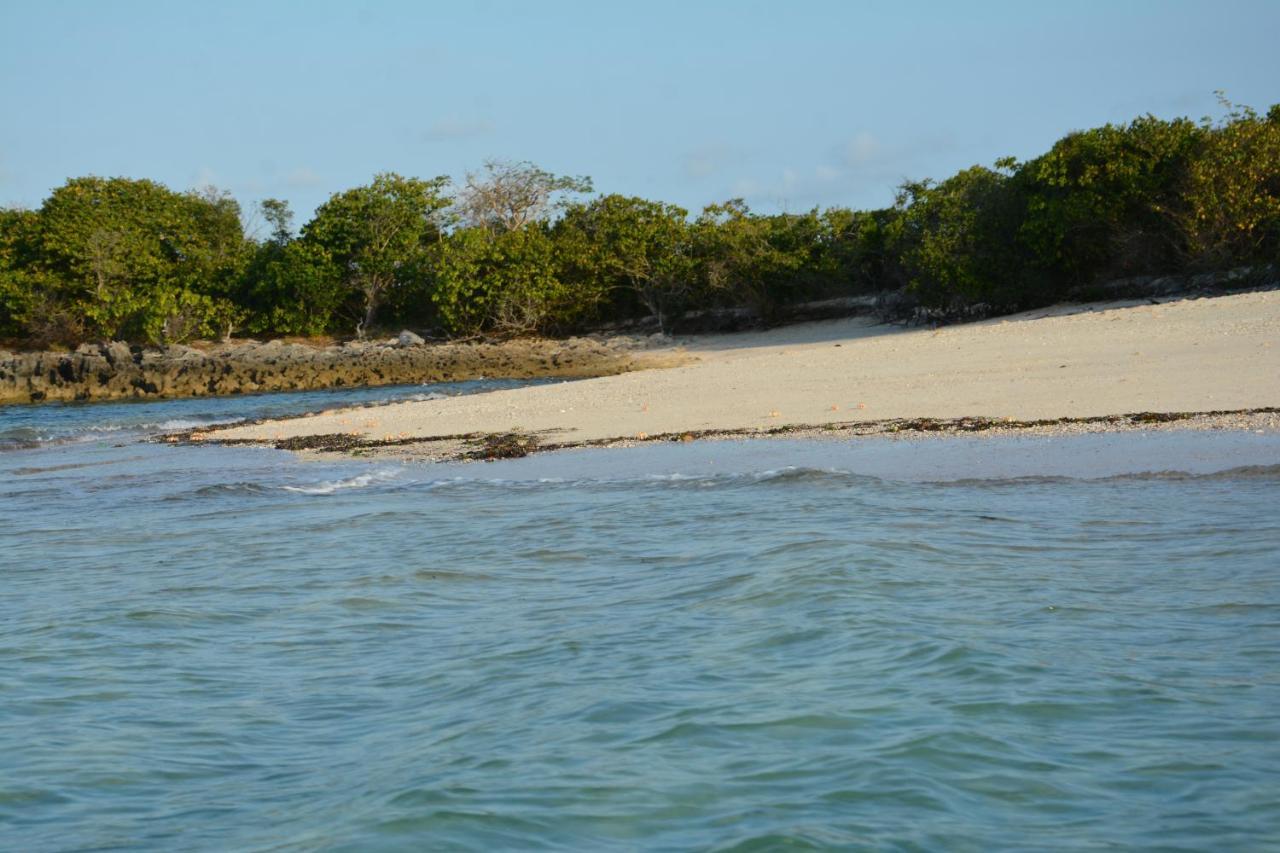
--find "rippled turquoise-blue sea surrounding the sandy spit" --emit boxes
[0,383,1280,850]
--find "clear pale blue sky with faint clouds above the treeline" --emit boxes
[0,0,1280,224]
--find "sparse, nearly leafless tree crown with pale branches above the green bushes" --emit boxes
[457,160,591,232]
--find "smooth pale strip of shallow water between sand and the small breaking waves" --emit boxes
[394,421,1280,488]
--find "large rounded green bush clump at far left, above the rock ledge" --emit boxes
[0,178,252,345]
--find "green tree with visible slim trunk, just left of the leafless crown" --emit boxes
[302,172,451,334]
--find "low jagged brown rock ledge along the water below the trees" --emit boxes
[0,336,632,403]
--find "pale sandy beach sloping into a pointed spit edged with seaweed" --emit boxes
[209,291,1280,457]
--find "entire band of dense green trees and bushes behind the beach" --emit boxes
[0,100,1280,347]
